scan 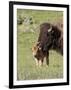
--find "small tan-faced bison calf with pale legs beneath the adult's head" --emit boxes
[32,42,49,66]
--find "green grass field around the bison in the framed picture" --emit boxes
[17,9,63,80]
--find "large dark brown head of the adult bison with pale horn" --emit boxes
[39,23,61,51]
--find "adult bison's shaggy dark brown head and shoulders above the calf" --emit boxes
[38,23,63,55]
